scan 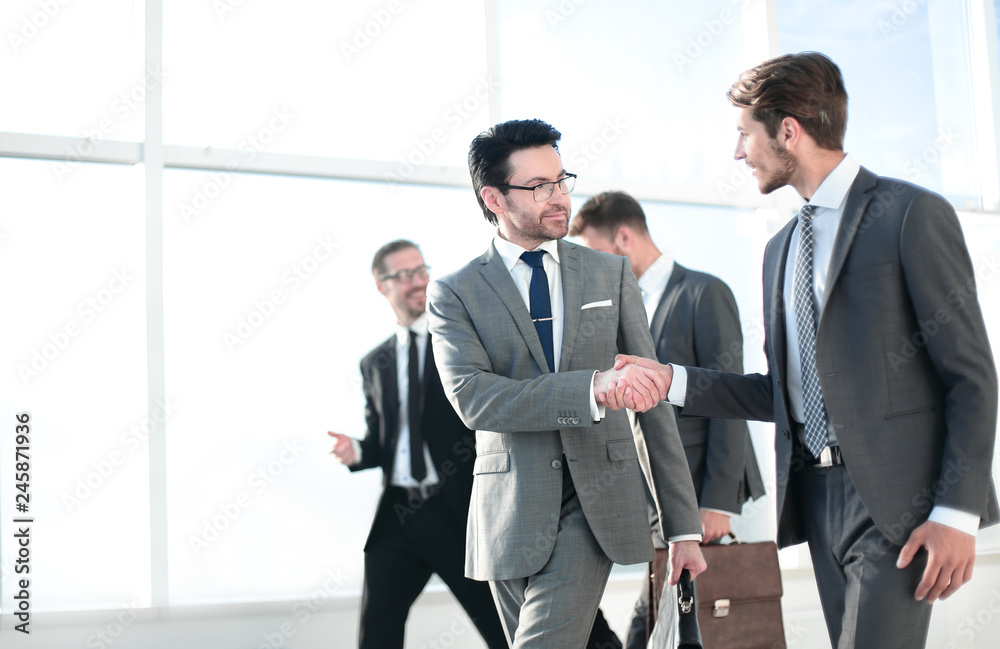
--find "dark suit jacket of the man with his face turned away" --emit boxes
[650,263,764,514]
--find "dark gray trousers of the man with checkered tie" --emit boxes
[789,465,931,649]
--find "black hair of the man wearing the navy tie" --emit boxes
[469,119,562,225]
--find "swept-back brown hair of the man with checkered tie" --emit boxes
[726,52,847,151]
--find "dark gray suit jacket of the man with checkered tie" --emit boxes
[683,168,1000,546]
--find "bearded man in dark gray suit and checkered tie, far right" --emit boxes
[610,52,1000,649]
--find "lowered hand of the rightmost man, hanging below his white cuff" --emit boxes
[896,521,976,604]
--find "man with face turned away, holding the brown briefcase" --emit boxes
[569,192,764,649]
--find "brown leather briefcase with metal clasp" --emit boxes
[650,535,785,649]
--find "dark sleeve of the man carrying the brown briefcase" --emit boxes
[694,278,750,514]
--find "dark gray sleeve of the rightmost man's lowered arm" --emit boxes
[897,193,997,513]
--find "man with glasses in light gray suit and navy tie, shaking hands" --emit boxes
[428,120,705,649]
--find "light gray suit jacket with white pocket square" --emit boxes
[427,241,701,580]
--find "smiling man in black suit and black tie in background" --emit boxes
[328,239,507,649]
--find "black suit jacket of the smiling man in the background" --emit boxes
[349,336,476,548]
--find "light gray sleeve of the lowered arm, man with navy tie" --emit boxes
[619,258,701,539]
